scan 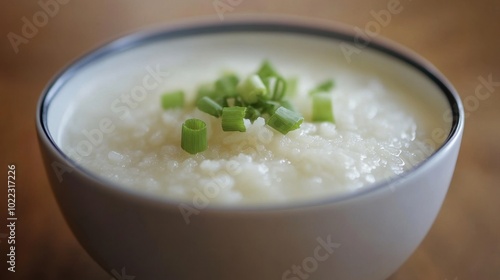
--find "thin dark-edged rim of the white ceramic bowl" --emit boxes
[36,16,465,212]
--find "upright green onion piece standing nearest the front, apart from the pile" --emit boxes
[181,119,208,155]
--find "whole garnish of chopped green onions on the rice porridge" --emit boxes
[170,60,306,149]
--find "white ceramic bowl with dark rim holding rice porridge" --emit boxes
[37,20,464,280]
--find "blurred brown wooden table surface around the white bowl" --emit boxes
[0,0,500,280]
